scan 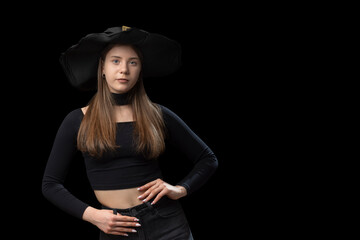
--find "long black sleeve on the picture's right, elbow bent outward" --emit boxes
[161,106,218,195]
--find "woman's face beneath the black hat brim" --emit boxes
[102,45,141,93]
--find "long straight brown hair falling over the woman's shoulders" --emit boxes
[77,44,165,159]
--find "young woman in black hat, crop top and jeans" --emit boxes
[42,27,218,240]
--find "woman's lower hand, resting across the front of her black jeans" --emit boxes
[83,207,140,236]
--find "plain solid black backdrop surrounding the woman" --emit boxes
[0,1,357,239]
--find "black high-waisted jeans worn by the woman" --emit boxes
[100,196,193,240]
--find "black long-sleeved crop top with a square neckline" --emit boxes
[42,105,218,218]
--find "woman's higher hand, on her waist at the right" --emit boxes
[138,178,187,204]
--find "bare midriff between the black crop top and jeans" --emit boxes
[94,188,143,209]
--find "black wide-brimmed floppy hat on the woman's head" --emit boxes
[60,26,181,90]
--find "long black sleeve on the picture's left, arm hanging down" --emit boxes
[42,109,88,219]
